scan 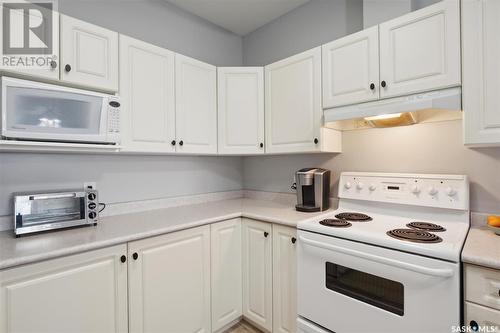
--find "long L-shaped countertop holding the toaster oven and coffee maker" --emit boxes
[0,198,331,269]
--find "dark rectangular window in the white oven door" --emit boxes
[326,262,404,316]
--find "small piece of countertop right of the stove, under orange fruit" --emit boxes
[462,227,500,270]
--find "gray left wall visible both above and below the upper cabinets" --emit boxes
[0,0,242,215]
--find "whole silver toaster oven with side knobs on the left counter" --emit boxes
[14,189,99,237]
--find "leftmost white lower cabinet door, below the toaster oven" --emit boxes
[0,245,128,333]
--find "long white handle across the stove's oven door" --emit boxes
[299,236,454,278]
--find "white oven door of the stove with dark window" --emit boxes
[297,230,460,333]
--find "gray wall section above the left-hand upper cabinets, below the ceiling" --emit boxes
[59,0,243,66]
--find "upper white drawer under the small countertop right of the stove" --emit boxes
[465,265,500,310]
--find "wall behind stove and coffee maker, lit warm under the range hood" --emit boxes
[243,121,500,213]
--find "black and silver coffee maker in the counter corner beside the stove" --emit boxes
[295,168,330,212]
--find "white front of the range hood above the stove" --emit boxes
[324,87,462,123]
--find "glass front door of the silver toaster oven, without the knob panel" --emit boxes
[14,192,86,235]
